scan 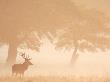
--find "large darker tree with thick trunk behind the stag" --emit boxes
[0,0,78,64]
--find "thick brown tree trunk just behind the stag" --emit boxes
[7,43,17,65]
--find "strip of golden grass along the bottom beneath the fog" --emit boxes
[0,76,110,82]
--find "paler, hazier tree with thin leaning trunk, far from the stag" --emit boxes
[56,10,110,63]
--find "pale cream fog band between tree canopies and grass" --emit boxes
[0,39,110,76]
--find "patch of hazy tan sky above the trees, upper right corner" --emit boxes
[72,0,110,16]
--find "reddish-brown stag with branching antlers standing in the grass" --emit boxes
[12,53,33,77]
